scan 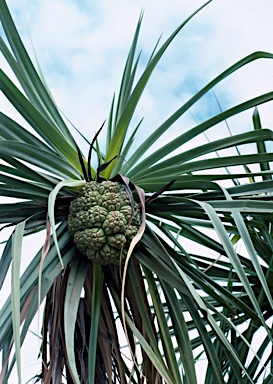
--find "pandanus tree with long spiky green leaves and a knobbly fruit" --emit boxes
[0,0,273,384]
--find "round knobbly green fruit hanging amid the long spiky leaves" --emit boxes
[68,181,141,264]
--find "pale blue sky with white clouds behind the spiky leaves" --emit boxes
[0,0,273,384]
